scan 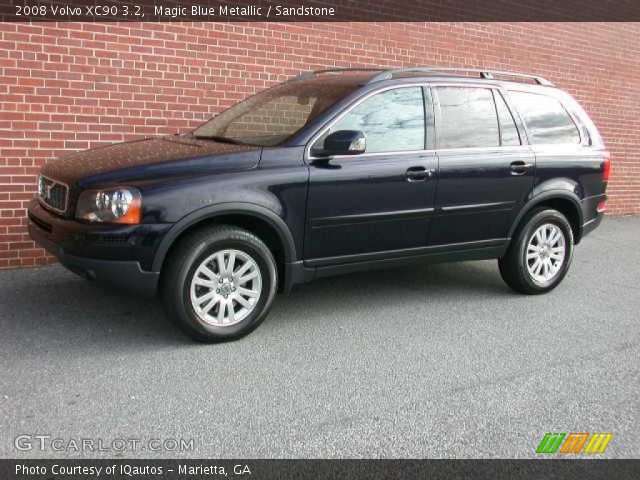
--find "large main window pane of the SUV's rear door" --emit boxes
[436,87,500,148]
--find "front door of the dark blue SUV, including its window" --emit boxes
[304,86,437,265]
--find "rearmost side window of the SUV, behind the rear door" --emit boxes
[509,92,580,144]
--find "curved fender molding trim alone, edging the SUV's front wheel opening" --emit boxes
[152,202,297,272]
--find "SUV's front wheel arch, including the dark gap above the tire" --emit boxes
[152,202,297,279]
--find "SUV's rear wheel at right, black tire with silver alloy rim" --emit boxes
[498,208,573,295]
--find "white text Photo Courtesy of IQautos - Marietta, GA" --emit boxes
[16,463,251,477]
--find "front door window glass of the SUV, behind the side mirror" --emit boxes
[313,87,425,153]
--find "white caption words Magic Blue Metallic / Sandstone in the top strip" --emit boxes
[154,5,336,18]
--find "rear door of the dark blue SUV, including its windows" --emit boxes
[430,85,535,246]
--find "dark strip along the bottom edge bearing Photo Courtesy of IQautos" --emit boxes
[0,459,640,480]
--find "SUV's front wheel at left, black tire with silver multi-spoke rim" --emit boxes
[162,225,278,342]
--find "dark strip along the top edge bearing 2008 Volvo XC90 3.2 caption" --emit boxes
[0,0,640,22]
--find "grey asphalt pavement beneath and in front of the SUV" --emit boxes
[0,216,640,458]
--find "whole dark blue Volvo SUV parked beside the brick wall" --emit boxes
[29,68,610,341]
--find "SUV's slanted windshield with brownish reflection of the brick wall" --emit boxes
[193,79,358,147]
